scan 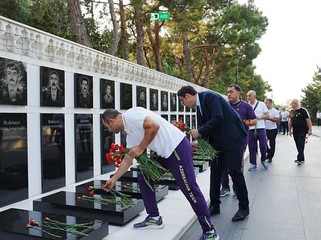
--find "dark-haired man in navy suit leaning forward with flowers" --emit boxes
[177,86,250,222]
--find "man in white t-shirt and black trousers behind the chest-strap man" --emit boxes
[265,98,280,163]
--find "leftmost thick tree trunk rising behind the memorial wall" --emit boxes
[68,0,91,47]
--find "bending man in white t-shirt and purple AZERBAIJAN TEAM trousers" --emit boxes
[102,107,219,240]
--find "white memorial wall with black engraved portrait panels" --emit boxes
[0,17,204,208]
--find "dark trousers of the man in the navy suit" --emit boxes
[210,141,249,209]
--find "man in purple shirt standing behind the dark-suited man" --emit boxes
[220,84,256,197]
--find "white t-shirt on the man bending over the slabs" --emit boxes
[122,107,186,158]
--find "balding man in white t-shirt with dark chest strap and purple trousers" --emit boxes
[247,90,269,172]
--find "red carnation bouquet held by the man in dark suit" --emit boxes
[173,119,217,159]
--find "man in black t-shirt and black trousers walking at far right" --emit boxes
[289,99,312,165]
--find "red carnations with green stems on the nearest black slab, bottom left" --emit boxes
[26,217,93,238]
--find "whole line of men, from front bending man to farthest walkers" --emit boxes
[102,84,312,240]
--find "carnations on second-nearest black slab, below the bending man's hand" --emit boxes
[77,186,135,208]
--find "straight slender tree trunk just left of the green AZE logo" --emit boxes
[134,9,145,66]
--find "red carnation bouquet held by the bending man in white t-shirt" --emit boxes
[106,143,167,183]
